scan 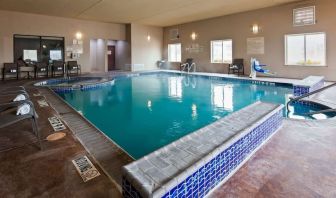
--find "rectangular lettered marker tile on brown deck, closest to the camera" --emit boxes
[72,155,100,182]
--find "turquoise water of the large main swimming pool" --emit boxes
[55,73,328,159]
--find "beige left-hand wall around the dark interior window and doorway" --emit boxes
[0,11,125,72]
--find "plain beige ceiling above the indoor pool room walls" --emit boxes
[0,0,300,26]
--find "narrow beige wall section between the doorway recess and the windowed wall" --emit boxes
[131,24,163,70]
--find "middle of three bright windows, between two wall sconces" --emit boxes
[211,39,232,64]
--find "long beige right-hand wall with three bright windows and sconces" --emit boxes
[164,0,336,80]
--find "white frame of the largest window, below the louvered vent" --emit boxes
[284,32,328,67]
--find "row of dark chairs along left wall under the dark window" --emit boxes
[2,61,81,81]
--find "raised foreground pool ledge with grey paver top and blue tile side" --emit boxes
[122,102,284,198]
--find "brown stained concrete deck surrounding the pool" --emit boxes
[0,70,336,197]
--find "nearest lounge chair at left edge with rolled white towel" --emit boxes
[0,100,43,150]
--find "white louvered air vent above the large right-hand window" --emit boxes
[293,6,315,26]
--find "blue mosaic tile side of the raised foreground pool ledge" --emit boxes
[122,103,283,198]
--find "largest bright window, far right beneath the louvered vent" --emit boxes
[285,33,326,66]
